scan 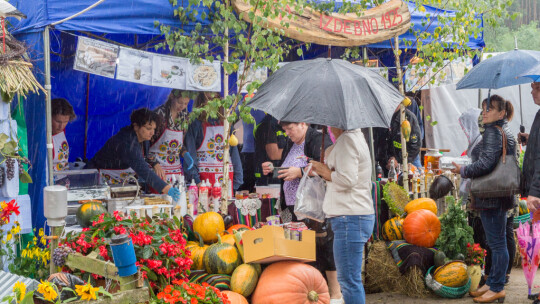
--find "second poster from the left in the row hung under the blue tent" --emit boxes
[116,47,154,85]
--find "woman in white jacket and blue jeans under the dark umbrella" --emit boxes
[312,127,375,304]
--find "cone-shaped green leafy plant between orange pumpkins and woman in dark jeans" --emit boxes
[435,196,474,260]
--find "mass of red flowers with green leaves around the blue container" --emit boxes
[60,212,193,290]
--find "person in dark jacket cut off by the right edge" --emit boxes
[518,82,540,212]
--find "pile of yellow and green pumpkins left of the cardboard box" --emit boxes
[184,212,262,303]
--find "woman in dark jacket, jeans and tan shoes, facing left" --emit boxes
[452,95,516,303]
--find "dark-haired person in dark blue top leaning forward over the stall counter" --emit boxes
[87,108,180,201]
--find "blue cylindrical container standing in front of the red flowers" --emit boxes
[111,234,137,277]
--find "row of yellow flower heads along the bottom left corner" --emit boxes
[2,280,112,304]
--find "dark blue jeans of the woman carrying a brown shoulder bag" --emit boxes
[480,209,509,292]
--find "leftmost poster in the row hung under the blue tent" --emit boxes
[73,36,119,78]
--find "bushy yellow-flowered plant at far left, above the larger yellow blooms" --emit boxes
[9,228,51,280]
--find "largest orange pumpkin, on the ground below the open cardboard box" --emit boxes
[251,261,330,304]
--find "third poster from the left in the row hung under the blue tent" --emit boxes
[152,55,189,90]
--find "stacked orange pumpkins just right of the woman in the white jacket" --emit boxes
[382,198,441,248]
